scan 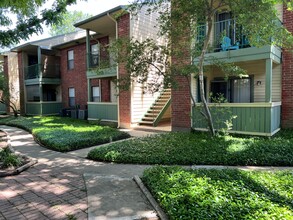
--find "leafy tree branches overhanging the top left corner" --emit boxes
[0,0,76,47]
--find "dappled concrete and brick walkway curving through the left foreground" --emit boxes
[0,126,156,220]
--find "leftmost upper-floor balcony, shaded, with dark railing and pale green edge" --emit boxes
[24,64,60,85]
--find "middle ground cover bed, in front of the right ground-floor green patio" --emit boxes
[88,130,293,166]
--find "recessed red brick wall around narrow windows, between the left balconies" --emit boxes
[60,43,88,109]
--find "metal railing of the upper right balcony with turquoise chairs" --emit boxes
[196,19,250,52]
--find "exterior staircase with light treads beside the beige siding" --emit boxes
[139,89,171,127]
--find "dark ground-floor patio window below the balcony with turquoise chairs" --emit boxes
[211,78,252,103]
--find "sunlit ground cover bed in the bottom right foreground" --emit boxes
[142,167,293,220]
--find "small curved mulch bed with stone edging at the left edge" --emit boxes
[0,130,37,177]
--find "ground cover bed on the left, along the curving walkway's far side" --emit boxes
[0,116,129,152]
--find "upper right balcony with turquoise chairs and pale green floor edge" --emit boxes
[194,19,281,65]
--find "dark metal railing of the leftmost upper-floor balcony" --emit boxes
[24,64,60,80]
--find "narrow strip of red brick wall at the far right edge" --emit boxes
[282,8,293,128]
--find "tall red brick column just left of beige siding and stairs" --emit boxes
[118,14,131,128]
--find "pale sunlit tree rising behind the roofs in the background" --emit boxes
[49,11,91,36]
